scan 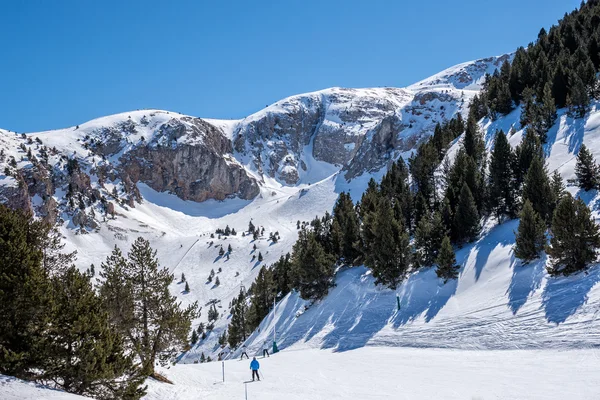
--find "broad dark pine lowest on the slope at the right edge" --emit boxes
[546,193,600,275]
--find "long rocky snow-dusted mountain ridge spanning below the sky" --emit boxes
[0,55,511,233]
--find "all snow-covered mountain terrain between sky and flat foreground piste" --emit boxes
[0,51,600,363]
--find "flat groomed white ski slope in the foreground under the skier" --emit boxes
[145,347,600,400]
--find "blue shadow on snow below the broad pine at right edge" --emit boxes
[542,266,600,325]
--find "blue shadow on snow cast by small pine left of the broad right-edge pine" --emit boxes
[506,254,546,315]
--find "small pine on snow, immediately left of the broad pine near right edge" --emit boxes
[514,200,546,263]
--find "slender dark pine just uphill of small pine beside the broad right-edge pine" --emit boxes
[523,157,553,222]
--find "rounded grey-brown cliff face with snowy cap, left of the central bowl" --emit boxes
[119,117,259,201]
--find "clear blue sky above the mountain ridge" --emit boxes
[0,0,580,132]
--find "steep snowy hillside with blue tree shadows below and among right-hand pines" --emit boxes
[237,103,600,351]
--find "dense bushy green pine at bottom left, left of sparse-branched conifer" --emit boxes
[41,267,145,399]
